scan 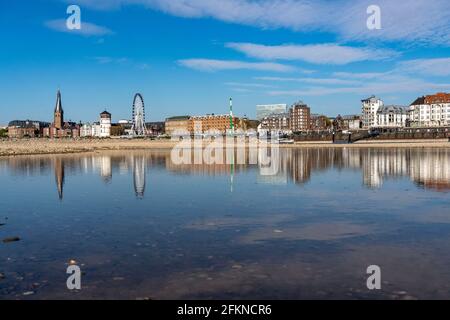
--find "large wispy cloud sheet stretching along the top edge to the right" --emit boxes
[63,0,450,45]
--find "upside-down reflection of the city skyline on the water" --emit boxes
[0,148,450,199]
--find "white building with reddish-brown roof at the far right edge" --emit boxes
[409,93,450,127]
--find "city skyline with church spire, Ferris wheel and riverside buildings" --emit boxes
[8,89,450,138]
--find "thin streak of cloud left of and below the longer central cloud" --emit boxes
[178,59,295,72]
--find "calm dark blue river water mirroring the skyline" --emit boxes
[0,149,450,299]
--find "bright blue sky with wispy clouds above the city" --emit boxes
[0,0,450,124]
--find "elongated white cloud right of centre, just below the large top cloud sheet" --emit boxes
[226,43,397,65]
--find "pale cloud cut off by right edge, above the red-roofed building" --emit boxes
[400,58,450,76]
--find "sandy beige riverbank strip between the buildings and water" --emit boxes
[0,139,450,156]
